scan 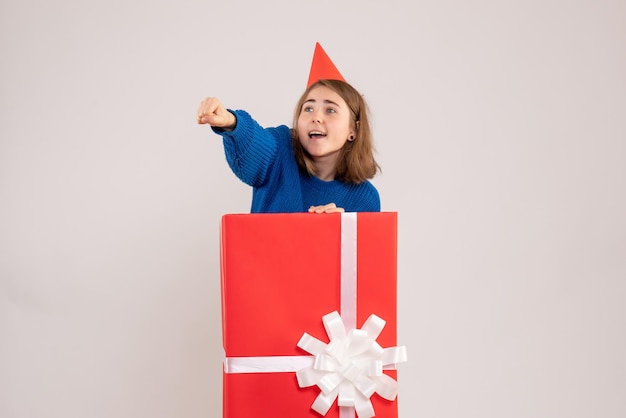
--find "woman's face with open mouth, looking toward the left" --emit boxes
[296,86,356,167]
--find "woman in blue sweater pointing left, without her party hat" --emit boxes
[198,79,380,213]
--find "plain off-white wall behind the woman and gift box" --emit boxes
[0,0,626,418]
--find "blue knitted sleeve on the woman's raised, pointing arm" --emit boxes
[213,109,280,187]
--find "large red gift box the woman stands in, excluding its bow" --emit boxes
[221,212,404,418]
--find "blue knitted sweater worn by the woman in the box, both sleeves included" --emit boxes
[213,110,380,213]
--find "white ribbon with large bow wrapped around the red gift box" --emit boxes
[224,212,407,418]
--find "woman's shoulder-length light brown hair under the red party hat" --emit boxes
[291,80,380,183]
